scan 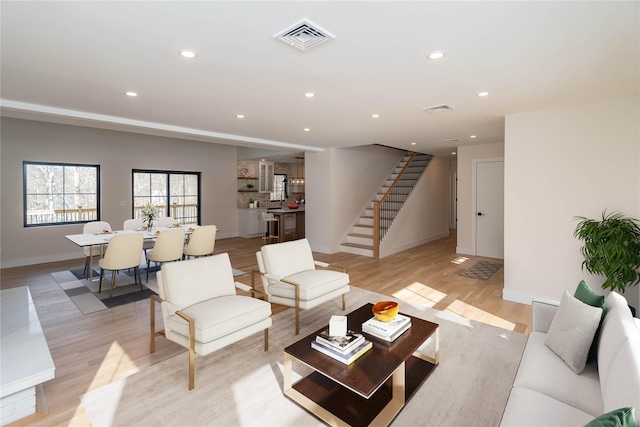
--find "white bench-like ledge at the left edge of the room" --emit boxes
[0,286,56,426]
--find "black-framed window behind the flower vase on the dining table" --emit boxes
[132,170,200,224]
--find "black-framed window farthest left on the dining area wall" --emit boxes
[23,162,100,227]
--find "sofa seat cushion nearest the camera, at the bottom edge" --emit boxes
[500,388,593,427]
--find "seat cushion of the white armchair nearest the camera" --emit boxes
[165,295,271,343]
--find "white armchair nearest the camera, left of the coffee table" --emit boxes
[150,253,271,390]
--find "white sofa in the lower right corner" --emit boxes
[501,292,640,426]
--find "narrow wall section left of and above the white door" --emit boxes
[456,143,505,255]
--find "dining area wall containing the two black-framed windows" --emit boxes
[0,117,238,268]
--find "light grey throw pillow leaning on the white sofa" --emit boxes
[544,291,602,374]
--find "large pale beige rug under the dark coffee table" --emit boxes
[81,287,526,426]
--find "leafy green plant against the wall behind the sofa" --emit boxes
[573,210,640,310]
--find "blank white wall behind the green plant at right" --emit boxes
[504,98,640,308]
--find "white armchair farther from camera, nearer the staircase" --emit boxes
[251,239,349,335]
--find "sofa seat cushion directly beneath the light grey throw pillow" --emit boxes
[513,332,604,418]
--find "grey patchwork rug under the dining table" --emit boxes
[51,263,246,314]
